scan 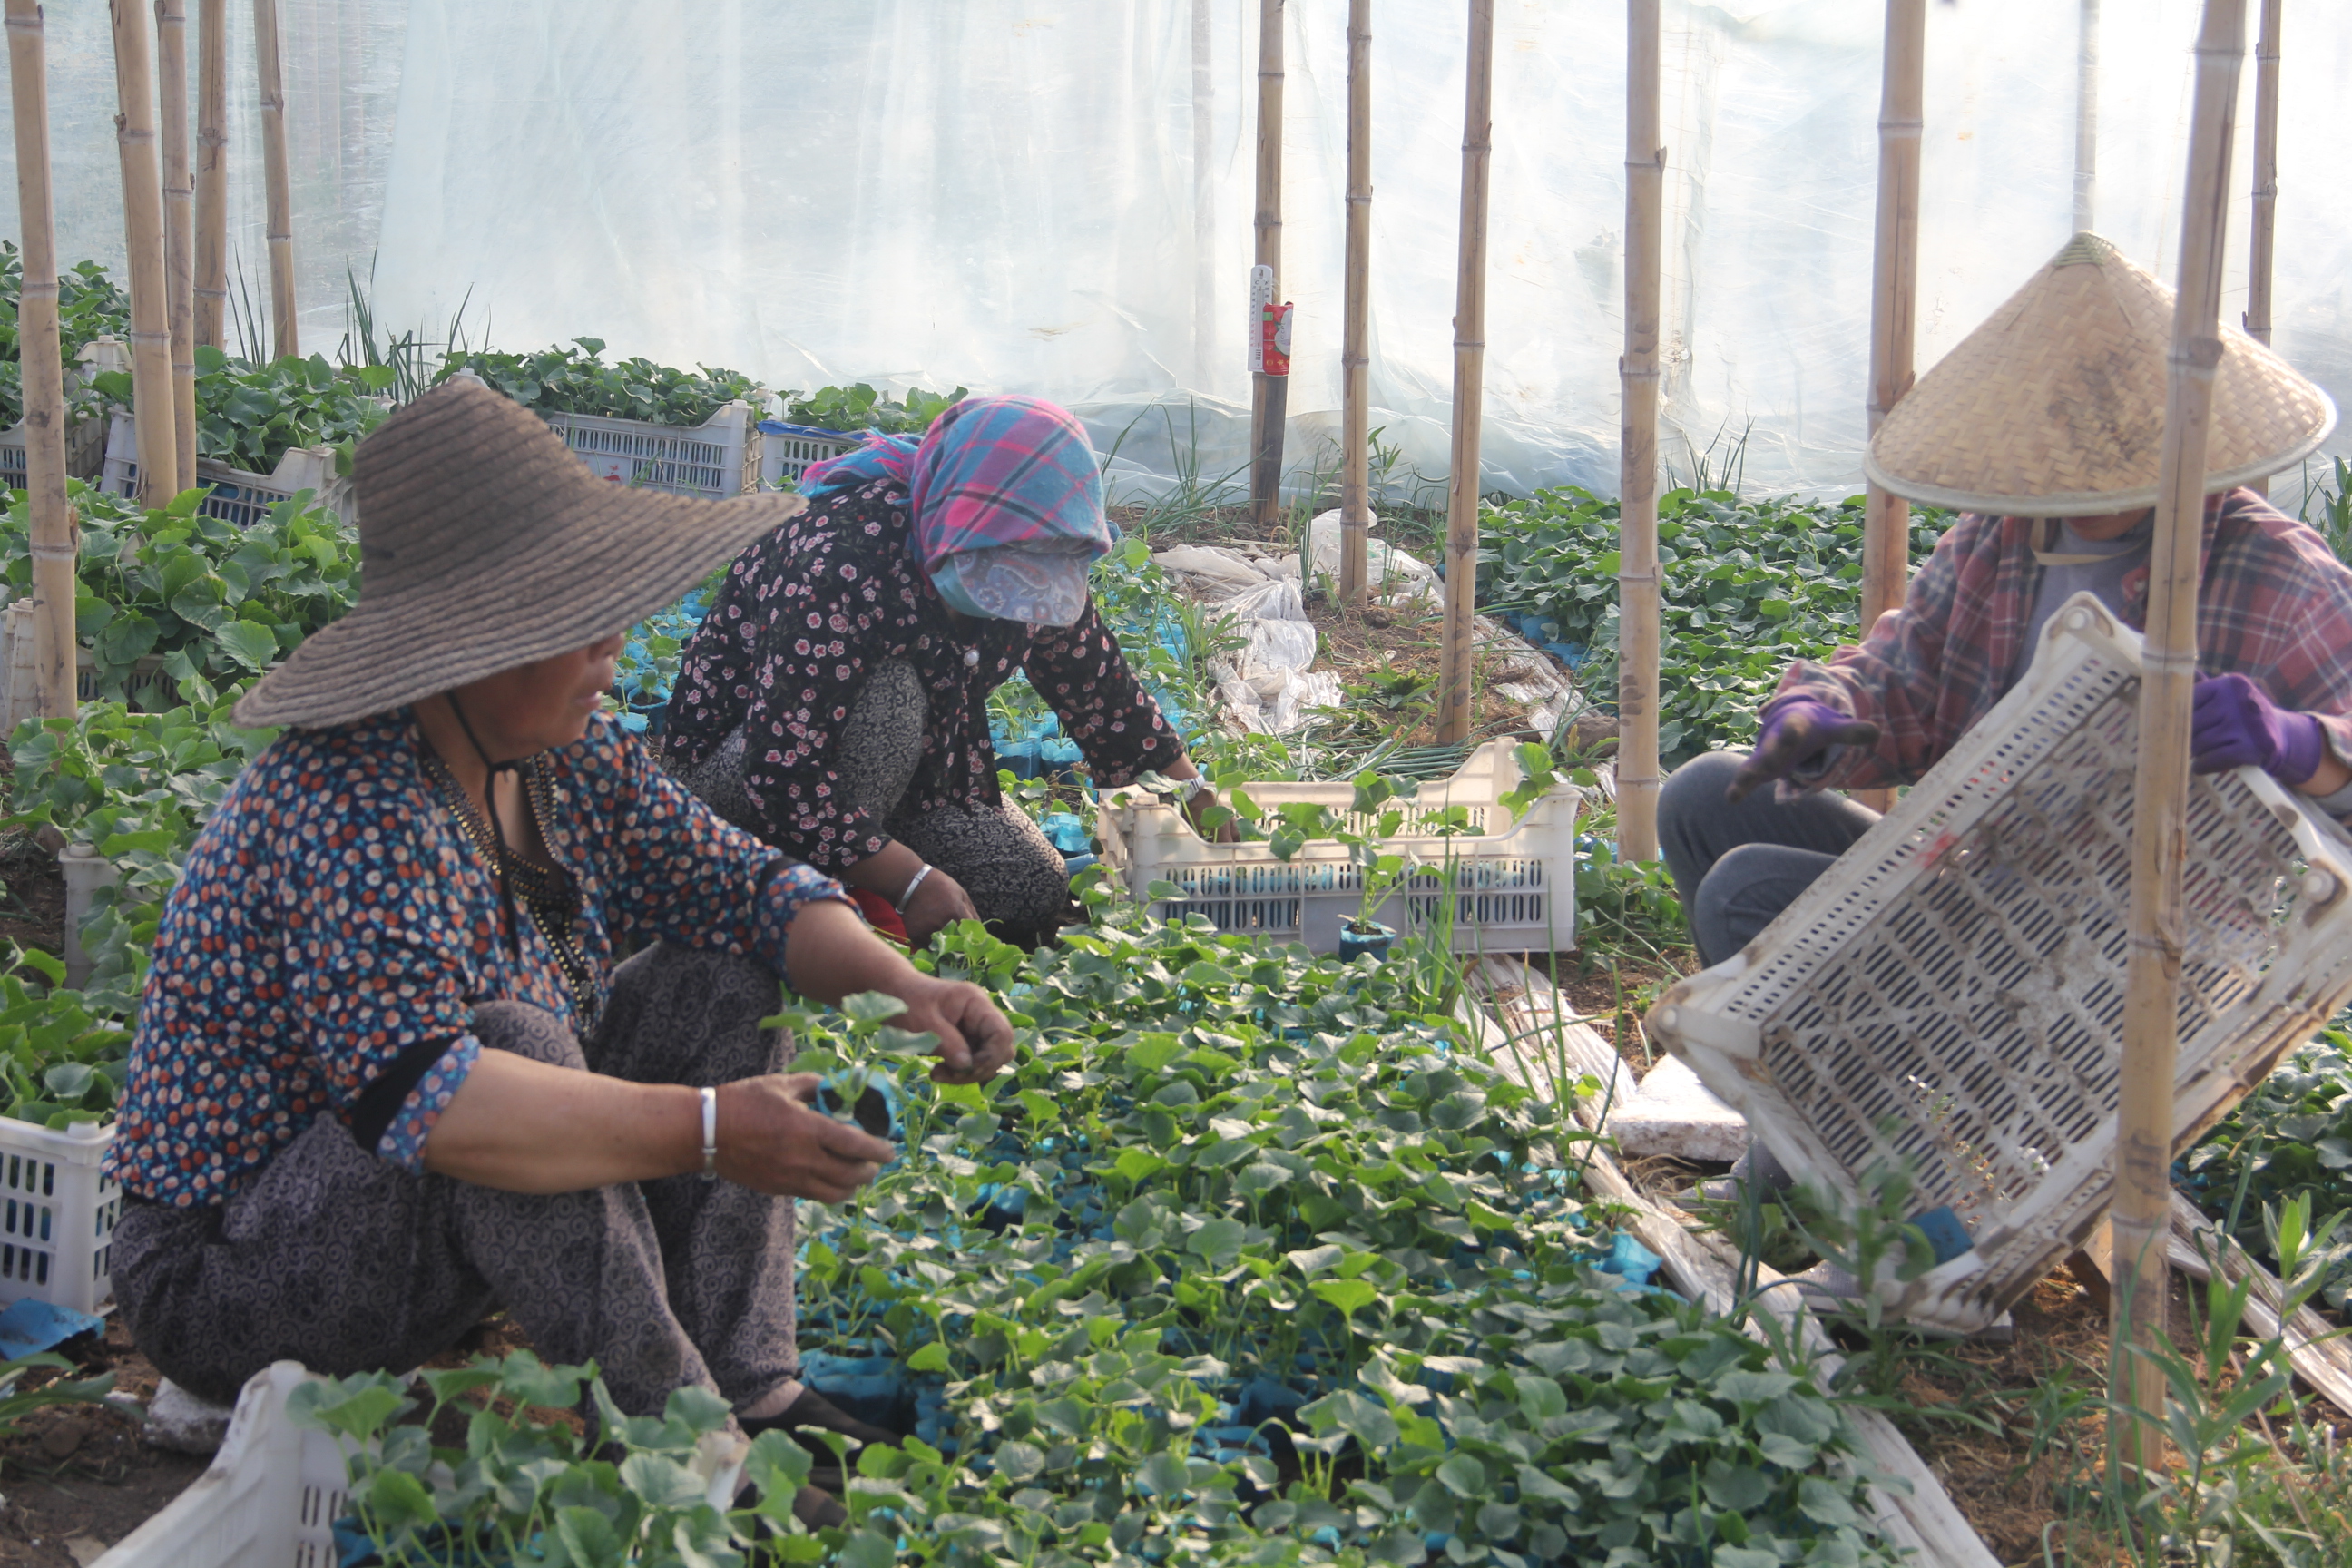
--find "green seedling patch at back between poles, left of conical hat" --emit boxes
[1479,486,1950,767]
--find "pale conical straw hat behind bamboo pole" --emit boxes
[1863,235,2336,517]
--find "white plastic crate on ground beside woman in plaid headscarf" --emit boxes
[1096,740,1583,952]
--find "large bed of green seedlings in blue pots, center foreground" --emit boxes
[317,916,1894,1568]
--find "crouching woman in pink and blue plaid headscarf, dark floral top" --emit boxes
[663,397,1211,945]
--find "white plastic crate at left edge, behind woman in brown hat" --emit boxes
[0,1117,122,1312]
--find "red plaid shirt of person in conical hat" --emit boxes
[1767,489,2352,808]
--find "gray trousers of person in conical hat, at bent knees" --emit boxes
[1658,752,1879,964]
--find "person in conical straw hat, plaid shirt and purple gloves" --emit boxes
[1658,235,2352,964]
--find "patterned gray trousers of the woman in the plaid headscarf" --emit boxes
[677,661,1077,947]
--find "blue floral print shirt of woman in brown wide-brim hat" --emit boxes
[108,710,847,1206]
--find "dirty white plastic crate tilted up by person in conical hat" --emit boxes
[1649,594,2352,1333]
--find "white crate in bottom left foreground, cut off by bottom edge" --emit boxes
[96,1361,350,1568]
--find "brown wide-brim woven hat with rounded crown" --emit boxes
[238,381,804,729]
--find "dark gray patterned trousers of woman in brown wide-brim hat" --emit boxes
[113,945,799,1416]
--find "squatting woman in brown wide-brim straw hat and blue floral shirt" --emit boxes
[111,383,1012,1523]
